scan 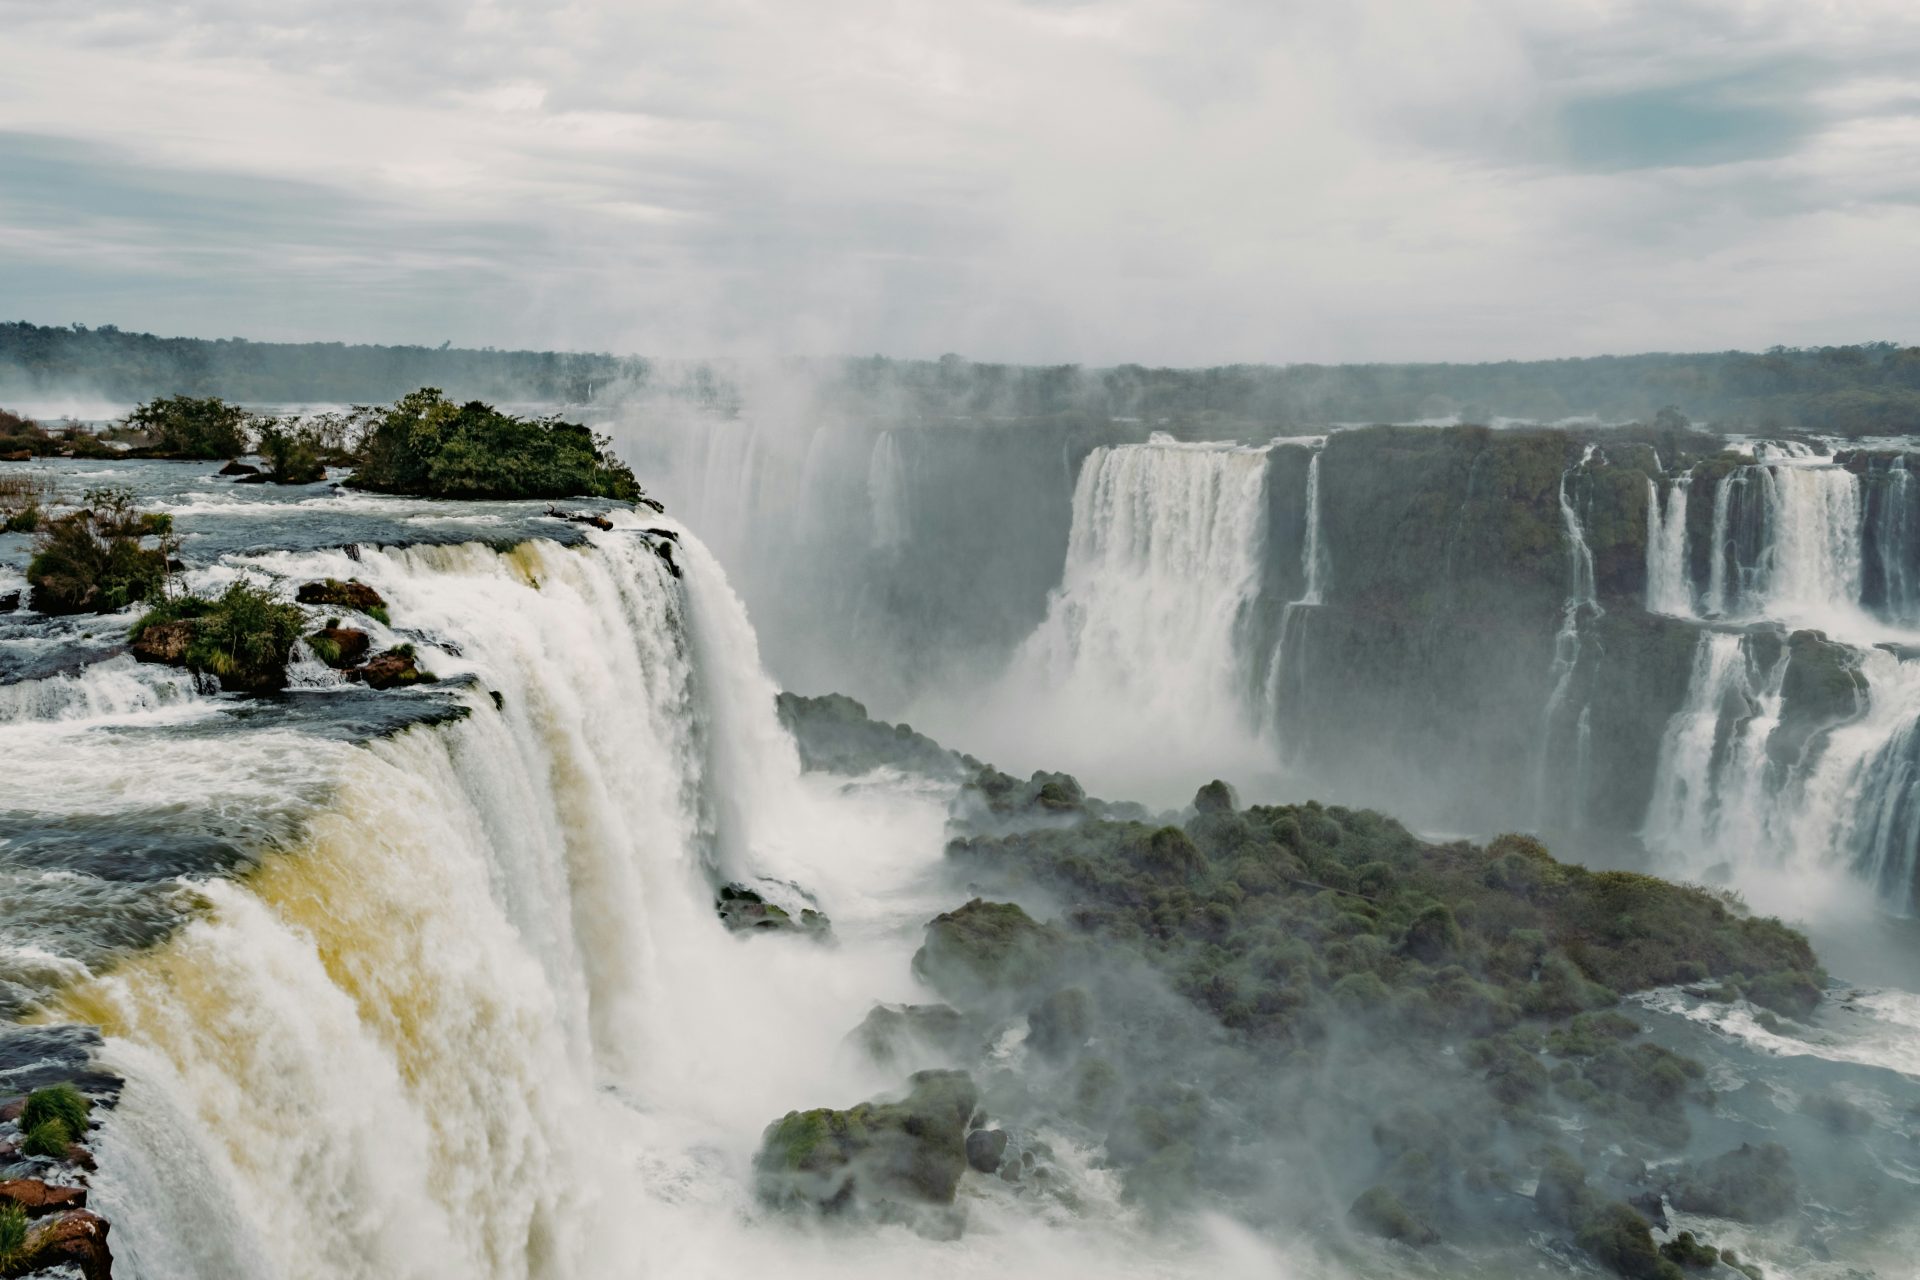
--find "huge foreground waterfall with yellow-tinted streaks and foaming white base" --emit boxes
[27,521,1325,1280]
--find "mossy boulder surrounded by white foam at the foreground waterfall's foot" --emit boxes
[755,1071,979,1215]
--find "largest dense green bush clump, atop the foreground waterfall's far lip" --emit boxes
[353,388,643,503]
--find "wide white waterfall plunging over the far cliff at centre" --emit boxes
[970,436,1273,802]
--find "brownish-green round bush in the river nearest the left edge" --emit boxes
[27,489,173,614]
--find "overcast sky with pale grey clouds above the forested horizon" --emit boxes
[0,0,1920,365]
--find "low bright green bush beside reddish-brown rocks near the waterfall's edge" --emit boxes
[132,581,307,693]
